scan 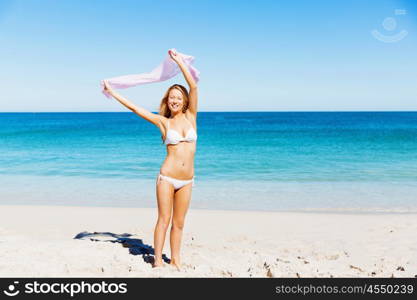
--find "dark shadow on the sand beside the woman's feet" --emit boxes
[74,231,171,264]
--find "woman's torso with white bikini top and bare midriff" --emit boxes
[160,114,197,180]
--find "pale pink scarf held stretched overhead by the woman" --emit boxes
[101,49,200,98]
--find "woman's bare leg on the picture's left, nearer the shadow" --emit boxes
[154,178,174,267]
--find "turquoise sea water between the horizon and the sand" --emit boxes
[0,112,417,211]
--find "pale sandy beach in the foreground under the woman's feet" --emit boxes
[0,206,417,277]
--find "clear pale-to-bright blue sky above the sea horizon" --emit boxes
[0,0,417,112]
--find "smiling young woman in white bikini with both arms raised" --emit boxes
[104,52,197,269]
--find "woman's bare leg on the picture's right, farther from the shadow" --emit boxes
[170,183,192,269]
